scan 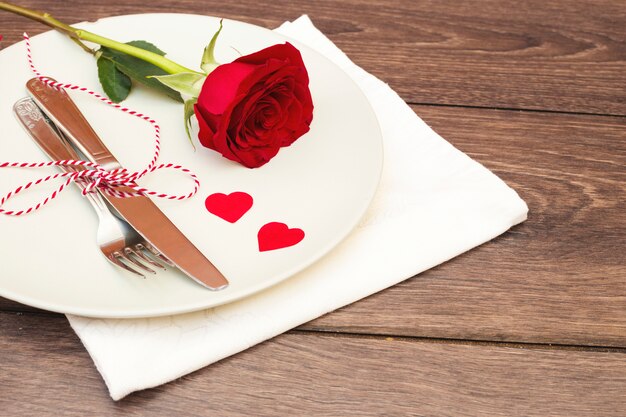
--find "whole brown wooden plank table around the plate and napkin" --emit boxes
[0,0,626,416]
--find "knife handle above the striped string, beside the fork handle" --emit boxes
[26,78,120,170]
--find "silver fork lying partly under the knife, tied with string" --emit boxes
[13,98,172,276]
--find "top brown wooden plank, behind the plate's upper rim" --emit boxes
[0,0,626,115]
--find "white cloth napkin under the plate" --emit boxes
[68,16,528,400]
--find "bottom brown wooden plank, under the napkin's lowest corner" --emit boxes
[0,313,626,417]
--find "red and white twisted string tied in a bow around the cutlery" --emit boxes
[0,33,200,216]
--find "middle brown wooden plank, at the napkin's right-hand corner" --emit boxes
[304,107,626,347]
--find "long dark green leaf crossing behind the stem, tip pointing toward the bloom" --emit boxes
[98,41,183,103]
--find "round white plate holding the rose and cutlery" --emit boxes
[0,14,383,318]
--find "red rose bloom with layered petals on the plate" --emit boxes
[194,43,313,168]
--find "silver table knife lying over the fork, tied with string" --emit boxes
[26,78,228,290]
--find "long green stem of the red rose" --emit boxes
[0,1,200,74]
